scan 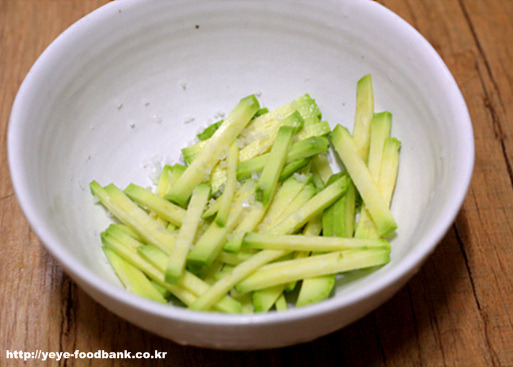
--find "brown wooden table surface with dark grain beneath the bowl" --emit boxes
[0,0,513,366]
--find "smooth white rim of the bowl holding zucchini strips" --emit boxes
[7,0,475,326]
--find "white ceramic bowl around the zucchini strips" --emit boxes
[8,0,474,349]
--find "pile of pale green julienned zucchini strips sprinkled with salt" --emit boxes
[90,75,400,313]
